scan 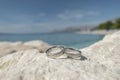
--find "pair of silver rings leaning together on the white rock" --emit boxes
[46,46,81,58]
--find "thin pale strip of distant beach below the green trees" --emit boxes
[76,30,119,35]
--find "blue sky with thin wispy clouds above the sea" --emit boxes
[0,0,120,33]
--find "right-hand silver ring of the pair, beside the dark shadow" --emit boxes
[64,48,81,58]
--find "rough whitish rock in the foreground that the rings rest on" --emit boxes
[0,32,120,80]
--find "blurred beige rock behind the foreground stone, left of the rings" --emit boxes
[0,40,50,57]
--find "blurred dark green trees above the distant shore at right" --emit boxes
[97,18,120,30]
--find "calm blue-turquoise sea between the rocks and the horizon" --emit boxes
[0,33,104,48]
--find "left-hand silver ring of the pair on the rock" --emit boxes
[46,46,64,58]
